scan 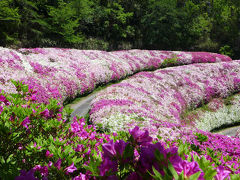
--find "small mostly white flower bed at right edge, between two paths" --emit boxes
[183,93,240,131]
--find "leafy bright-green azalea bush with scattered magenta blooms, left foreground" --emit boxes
[0,81,113,179]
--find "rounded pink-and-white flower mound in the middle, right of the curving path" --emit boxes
[90,61,240,134]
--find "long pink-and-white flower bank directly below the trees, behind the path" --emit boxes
[0,47,231,103]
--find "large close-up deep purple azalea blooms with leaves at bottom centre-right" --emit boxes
[83,127,239,180]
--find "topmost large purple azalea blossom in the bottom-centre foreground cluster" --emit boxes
[129,126,152,146]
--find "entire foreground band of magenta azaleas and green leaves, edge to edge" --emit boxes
[0,81,240,180]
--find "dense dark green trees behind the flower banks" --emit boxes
[0,0,240,58]
